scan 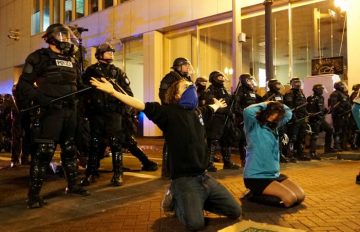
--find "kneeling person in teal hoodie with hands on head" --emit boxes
[244,101,305,207]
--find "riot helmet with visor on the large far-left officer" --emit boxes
[42,23,79,56]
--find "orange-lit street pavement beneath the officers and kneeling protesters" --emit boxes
[0,139,360,232]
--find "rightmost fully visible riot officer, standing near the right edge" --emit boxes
[328,81,351,150]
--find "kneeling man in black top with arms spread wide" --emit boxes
[91,79,241,231]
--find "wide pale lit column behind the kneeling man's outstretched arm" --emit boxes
[143,31,164,136]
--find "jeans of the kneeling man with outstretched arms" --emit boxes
[170,174,241,230]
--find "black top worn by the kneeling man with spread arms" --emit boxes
[144,102,214,179]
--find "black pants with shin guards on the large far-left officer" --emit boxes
[28,105,77,201]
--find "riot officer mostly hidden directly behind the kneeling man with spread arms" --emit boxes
[159,57,192,176]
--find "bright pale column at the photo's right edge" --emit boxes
[347,1,360,90]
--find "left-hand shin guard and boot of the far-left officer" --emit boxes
[27,144,55,209]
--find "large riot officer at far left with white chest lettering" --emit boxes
[18,23,89,208]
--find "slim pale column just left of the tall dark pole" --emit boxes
[232,0,242,91]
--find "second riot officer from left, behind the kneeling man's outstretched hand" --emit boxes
[81,43,133,186]
